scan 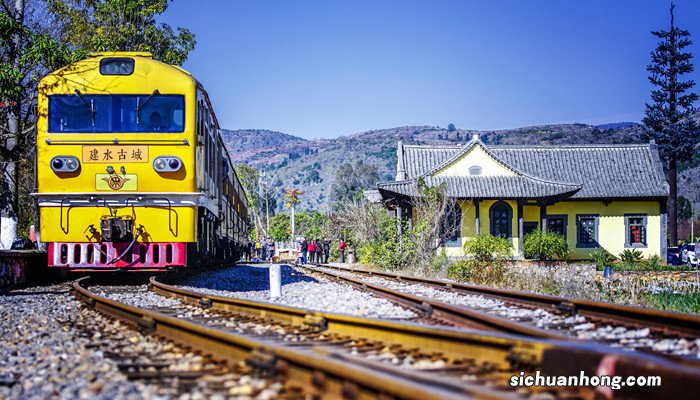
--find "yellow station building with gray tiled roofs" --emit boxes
[377,135,668,260]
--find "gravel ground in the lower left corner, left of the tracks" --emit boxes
[0,285,155,399]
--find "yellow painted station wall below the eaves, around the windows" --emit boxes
[444,200,662,259]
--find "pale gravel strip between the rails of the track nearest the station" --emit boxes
[321,268,700,358]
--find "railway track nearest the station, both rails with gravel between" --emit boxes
[304,265,700,364]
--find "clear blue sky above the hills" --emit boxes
[160,0,700,139]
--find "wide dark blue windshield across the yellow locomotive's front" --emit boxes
[49,90,185,133]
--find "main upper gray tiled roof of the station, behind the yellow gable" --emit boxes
[386,139,668,199]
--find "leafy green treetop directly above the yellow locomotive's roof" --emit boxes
[48,0,196,65]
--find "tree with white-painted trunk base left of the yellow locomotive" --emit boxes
[0,0,74,248]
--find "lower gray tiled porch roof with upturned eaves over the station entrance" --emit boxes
[377,175,581,199]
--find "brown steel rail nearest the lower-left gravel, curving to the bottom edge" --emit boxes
[72,277,512,400]
